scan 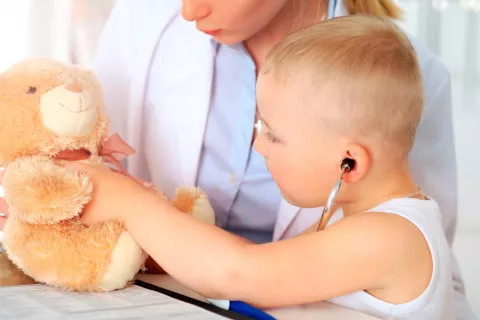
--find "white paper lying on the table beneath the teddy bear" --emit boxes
[0,284,226,320]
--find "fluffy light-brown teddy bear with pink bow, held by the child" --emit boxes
[0,58,215,291]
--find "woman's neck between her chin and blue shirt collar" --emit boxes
[244,0,328,70]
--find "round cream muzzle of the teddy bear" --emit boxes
[40,83,97,137]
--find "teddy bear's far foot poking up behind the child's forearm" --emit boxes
[172,188,215,224]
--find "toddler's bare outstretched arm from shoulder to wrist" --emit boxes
[126,198,428,307]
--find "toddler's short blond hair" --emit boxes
[261,14,423,157]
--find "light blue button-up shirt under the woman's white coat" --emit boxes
[197,44,281,242]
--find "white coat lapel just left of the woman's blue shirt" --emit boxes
[149,20,216,195]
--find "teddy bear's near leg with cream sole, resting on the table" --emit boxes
[11,221,147,291]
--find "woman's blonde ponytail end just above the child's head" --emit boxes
[345,0,404,19]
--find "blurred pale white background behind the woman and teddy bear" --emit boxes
[0,0,480,317]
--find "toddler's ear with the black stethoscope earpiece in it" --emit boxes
[343,144,372,183]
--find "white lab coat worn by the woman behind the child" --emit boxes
[94,0,473,319]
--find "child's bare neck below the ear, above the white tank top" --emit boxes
[341,165,419,216]
